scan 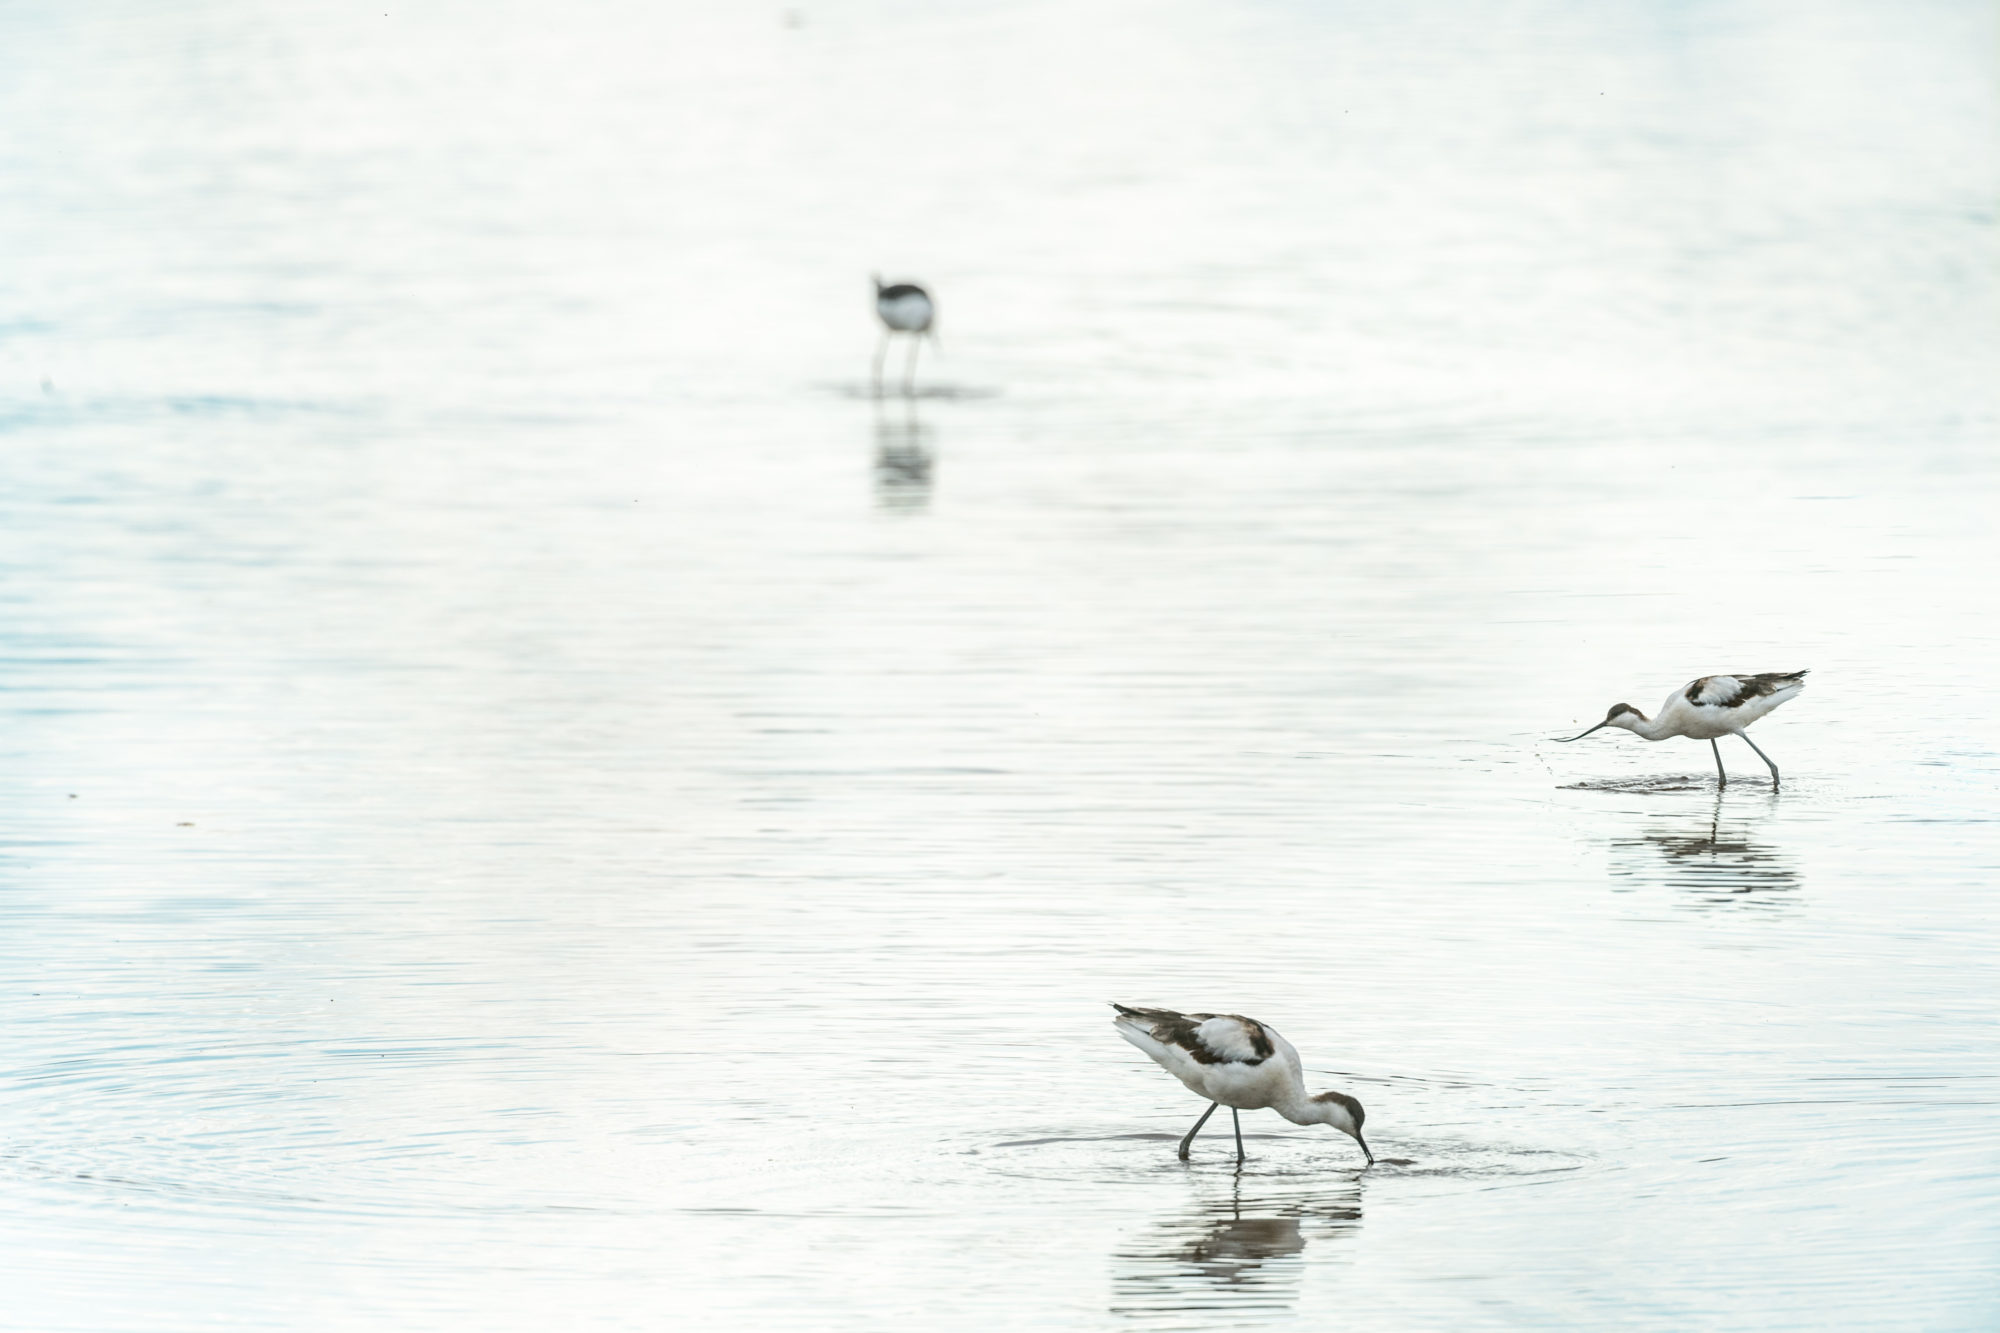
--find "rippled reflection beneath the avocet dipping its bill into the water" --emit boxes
[1112,1177,1362,1317]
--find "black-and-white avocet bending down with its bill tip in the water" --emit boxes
[1112,1003,1374,1167]
